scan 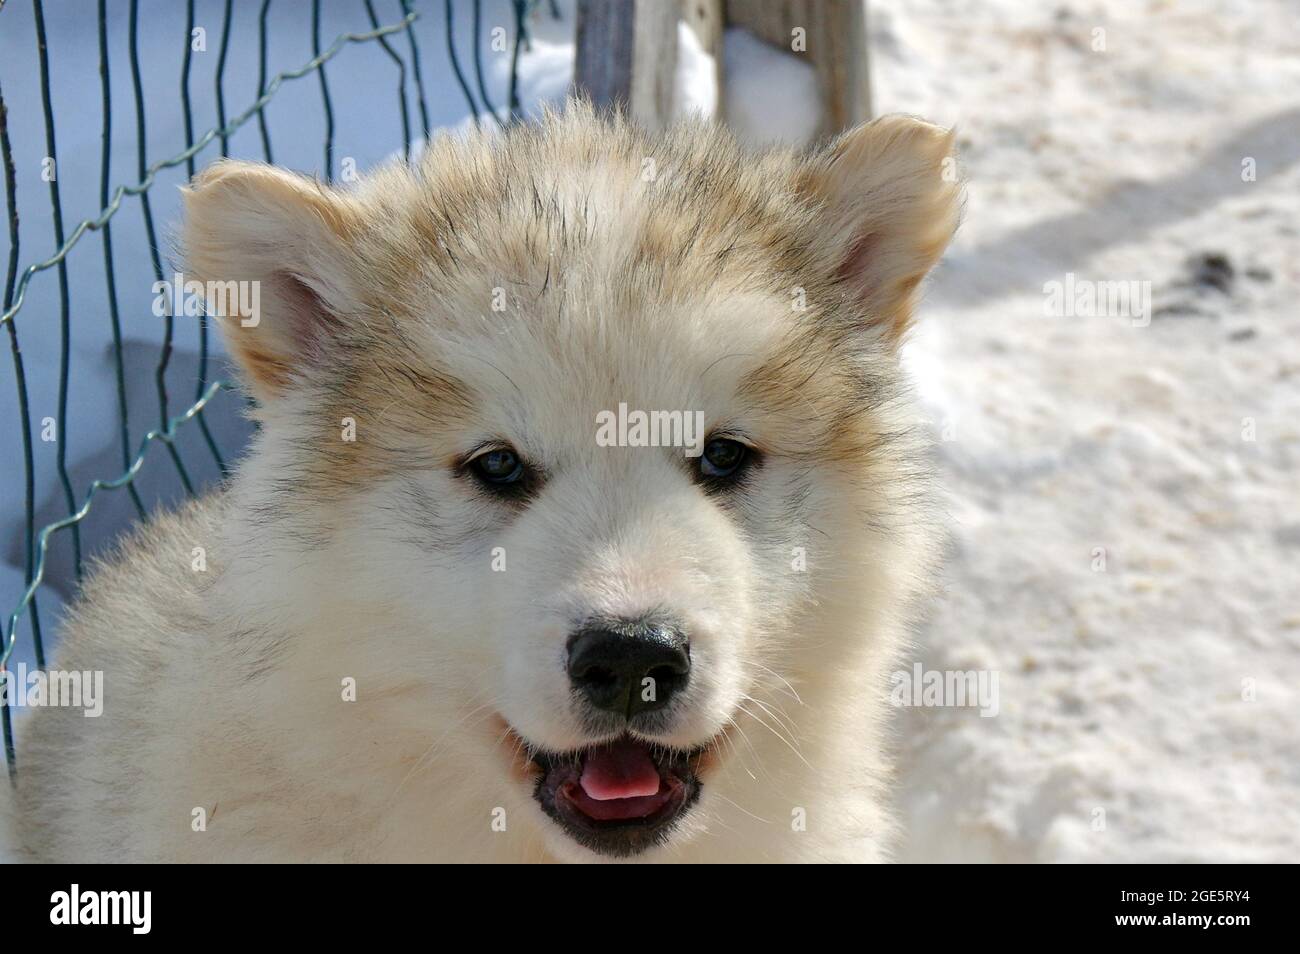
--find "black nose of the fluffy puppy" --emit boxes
[568,621,690,716]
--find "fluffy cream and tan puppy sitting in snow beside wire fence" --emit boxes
[12,103,961,862]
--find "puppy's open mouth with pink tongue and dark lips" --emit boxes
[533,736,702,857]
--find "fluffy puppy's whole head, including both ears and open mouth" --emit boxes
[186,107,958,857]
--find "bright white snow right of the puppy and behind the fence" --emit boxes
[3,0,1300,862]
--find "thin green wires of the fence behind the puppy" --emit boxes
[0,0,538,779]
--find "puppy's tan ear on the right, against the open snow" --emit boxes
[798,116,962,347]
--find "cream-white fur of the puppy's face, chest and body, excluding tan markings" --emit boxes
[0,106,950,862]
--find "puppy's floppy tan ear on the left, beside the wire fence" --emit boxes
[182,161,360,402]
